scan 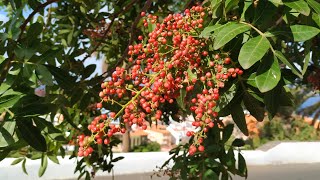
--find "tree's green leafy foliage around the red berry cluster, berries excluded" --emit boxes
[0,0,320,179]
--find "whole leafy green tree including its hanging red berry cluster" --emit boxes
[0,0,320,179]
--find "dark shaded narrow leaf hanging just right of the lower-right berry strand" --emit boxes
[231,104,249,136]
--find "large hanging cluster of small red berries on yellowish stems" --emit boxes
[78,6,243,156]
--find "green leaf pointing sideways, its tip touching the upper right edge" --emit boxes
[290,25,320,42]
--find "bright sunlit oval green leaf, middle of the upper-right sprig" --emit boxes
[238,35,270,69]
